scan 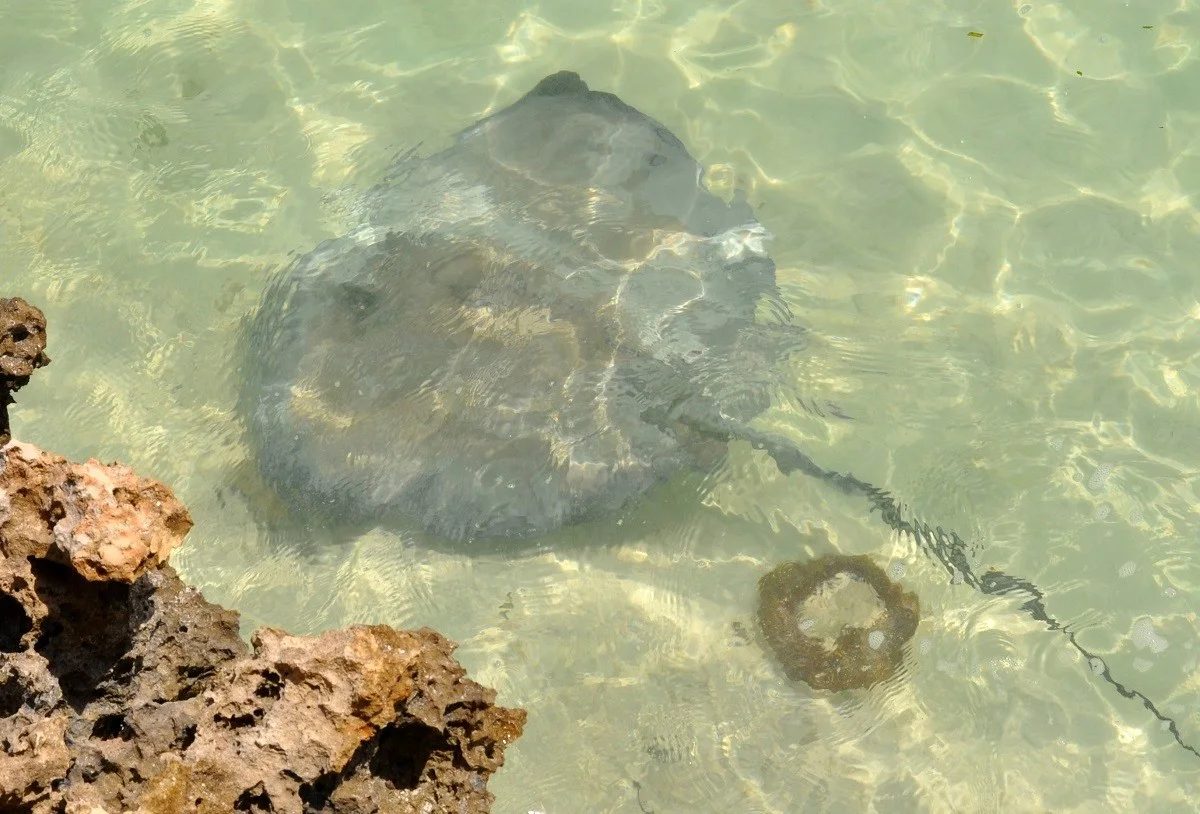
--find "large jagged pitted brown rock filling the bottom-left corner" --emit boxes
[0,301,526,814]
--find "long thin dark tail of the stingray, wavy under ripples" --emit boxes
[680,417,1200,758]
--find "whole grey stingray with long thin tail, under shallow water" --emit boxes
[240,71,1200,756]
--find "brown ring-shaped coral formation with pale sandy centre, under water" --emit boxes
[758,555,920,690]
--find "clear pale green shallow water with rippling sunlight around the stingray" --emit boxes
[0,0,1200,814]
